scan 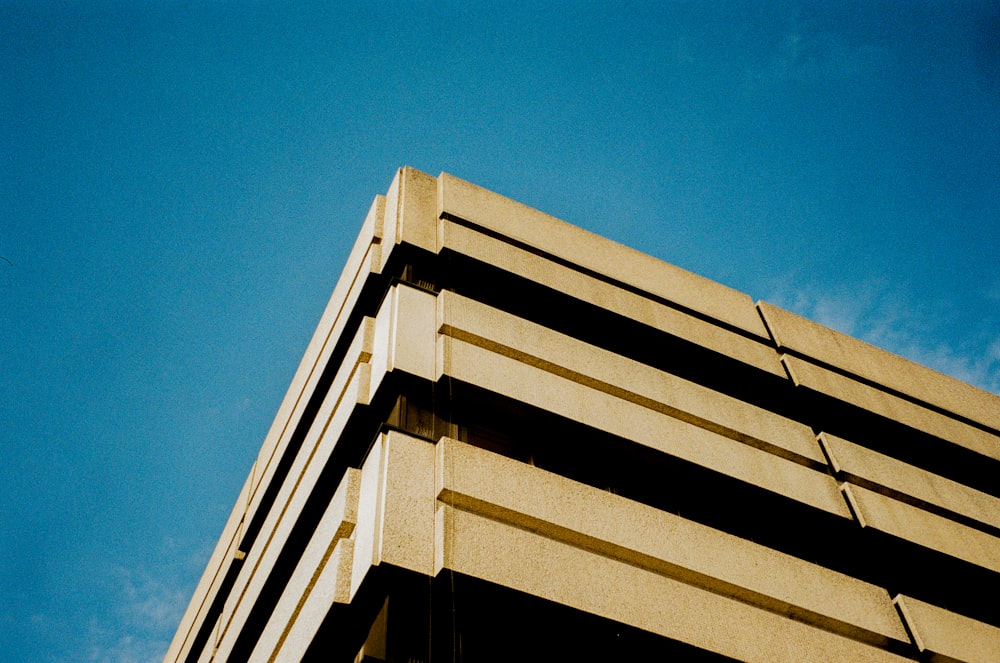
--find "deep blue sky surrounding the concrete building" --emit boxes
[0,0,1000,662]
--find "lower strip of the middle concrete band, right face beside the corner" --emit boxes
[438,336,851,518]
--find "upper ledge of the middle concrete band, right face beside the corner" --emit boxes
[438,292,826,468]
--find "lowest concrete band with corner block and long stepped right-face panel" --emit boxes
[336,431,908,661]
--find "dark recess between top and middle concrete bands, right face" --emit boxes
[430,246,1000,497]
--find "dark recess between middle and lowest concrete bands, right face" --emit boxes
[439,382,1000,625]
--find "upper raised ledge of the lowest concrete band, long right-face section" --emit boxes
[437,438,909,647]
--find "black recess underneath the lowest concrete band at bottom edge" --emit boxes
[303,567,732,663]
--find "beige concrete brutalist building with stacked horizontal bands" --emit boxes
[166,168,1000,663]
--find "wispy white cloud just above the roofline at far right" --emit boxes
[767,280,1000,394]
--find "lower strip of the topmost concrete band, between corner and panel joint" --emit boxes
[441,220,785,378]
